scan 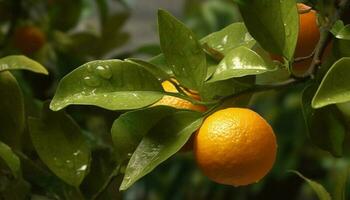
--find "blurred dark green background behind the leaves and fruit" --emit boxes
[0,0,350,200]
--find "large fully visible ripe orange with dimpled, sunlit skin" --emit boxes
[193,108,277,186]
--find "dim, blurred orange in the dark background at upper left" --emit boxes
[14,26,46,54]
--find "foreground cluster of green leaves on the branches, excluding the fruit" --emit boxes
[0,0,350,199]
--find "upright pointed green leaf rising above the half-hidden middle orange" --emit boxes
[158,10,207,91]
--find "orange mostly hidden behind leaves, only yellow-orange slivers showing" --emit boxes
[153,81,206,112]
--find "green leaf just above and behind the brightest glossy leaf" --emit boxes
[200,22,256,55]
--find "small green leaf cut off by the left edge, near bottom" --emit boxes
[0,141,21,178]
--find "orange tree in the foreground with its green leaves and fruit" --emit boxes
[0,0,350,199]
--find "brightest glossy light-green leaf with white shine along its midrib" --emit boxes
[208,46,275,82]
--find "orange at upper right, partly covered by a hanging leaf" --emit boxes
[271,3,320,73]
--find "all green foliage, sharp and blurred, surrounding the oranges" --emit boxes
[0,0,350,199]
